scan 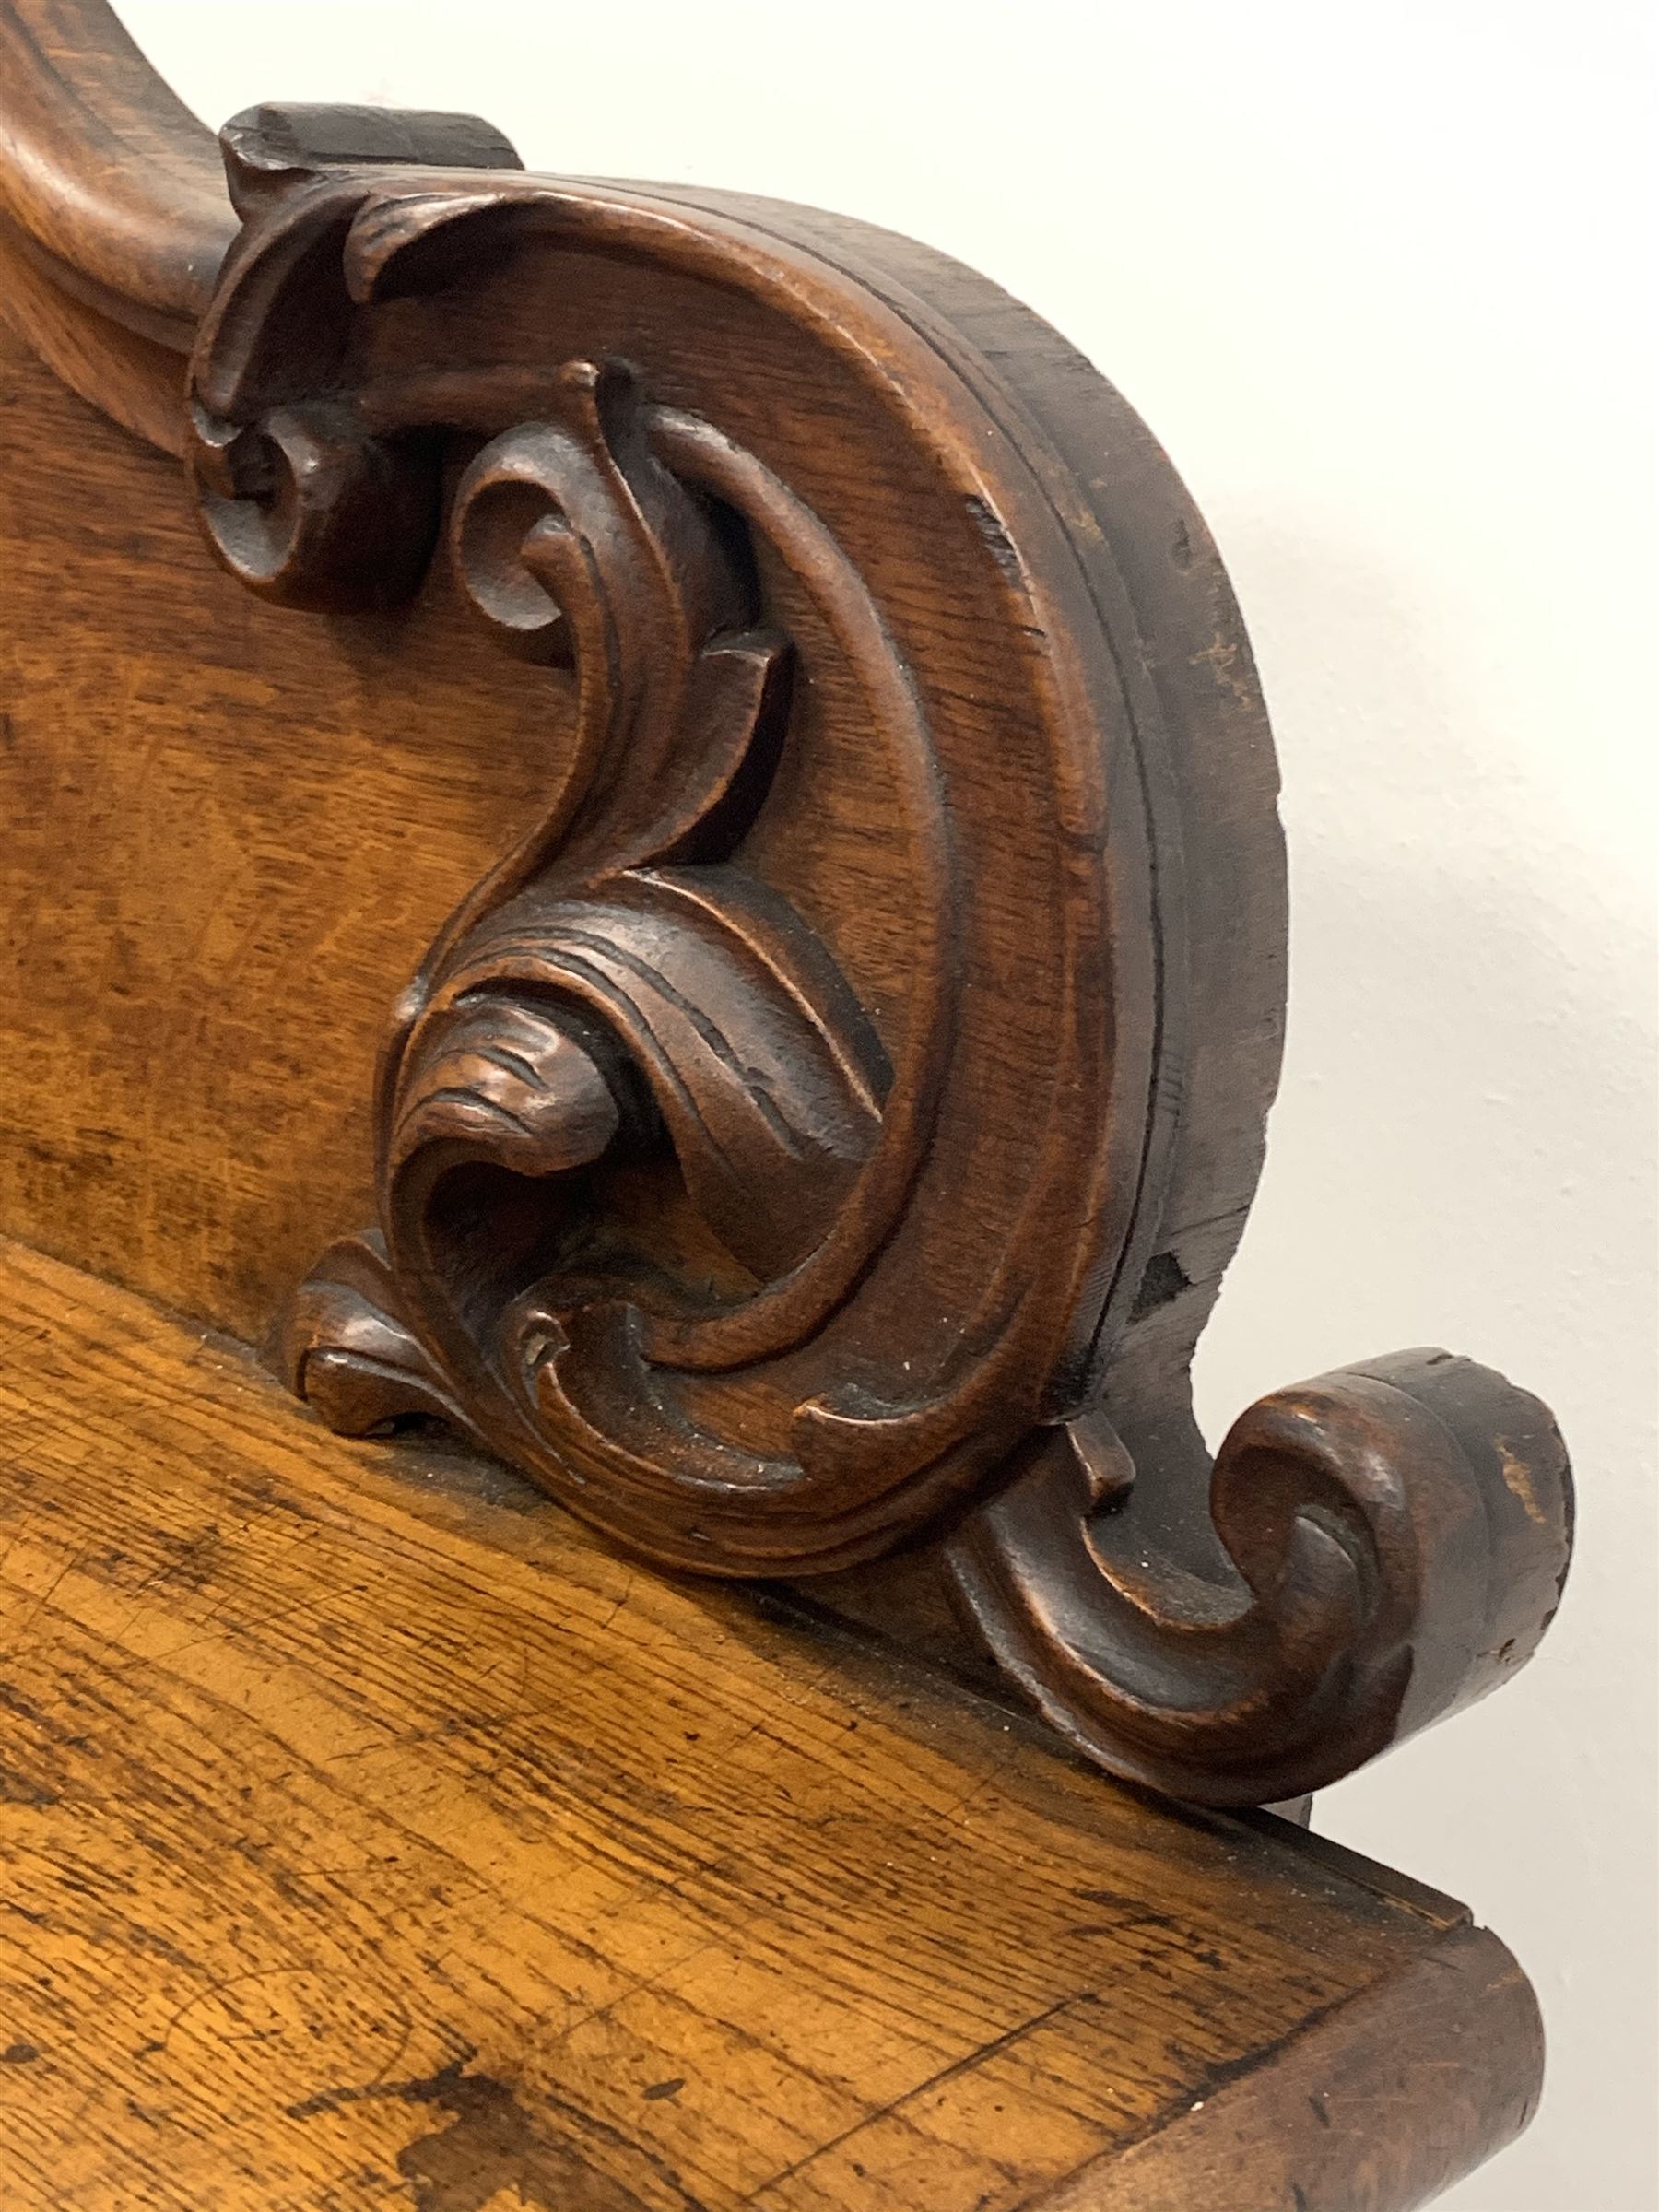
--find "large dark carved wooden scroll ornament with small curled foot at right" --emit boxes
[166,111,1569,1803]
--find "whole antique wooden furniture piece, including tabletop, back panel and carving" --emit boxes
[0,0,1571,2212]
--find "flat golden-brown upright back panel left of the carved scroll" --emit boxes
[0,307,566,1340]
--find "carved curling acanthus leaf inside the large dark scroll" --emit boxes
[382,363,889,1460]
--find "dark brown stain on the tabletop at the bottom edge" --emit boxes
[288,2051,690,2212]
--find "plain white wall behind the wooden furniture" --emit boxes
[120,0,1659,2212]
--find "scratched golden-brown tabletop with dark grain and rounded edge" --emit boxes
[0,1245,1537,2212]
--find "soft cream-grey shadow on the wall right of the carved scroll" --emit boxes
[1196,513,1659,2212]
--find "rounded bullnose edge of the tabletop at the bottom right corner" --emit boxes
[1030,1926,1544,2212]
